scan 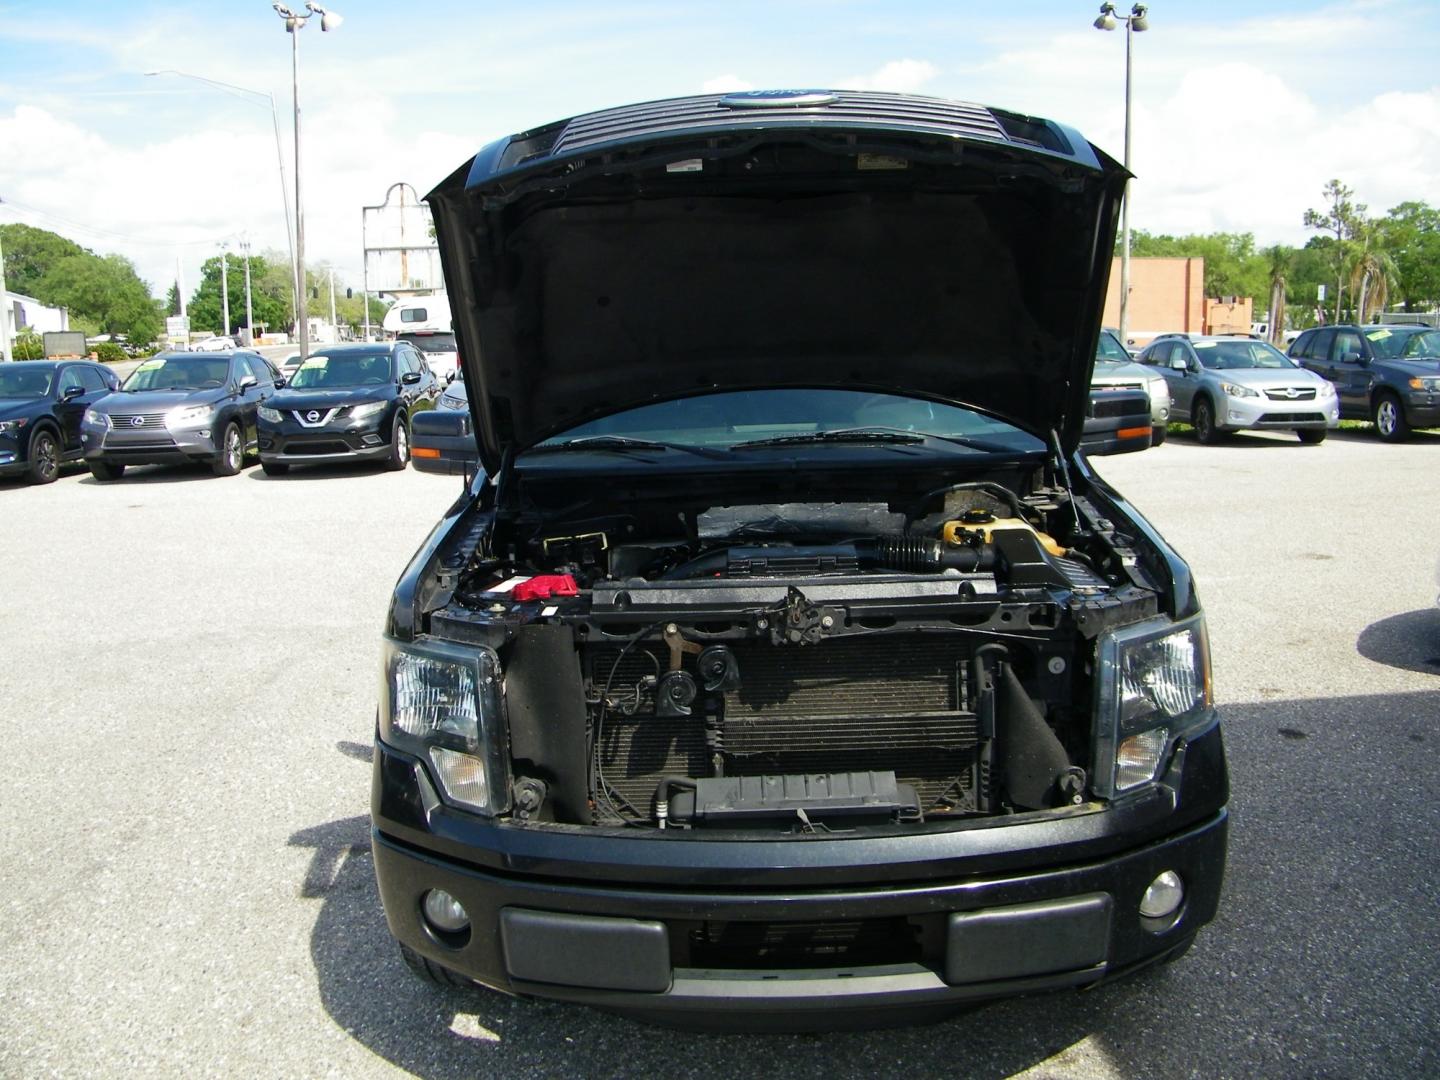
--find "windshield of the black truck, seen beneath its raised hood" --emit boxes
[524,390,1045,454]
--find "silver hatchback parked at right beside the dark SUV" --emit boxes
[1139,337,1341,444]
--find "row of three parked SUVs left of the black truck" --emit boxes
[0,341,442,484]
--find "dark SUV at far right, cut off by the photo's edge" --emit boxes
[1290,325,1440,442]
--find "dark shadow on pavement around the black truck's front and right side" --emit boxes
[289,690,1440,1080]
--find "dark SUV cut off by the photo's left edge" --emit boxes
[0,360,120,484]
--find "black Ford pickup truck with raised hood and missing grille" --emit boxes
[372,91,1227,1028]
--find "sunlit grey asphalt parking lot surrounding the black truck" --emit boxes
[0,432,1440,1080]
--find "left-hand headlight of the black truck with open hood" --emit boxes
[380,639,510,815]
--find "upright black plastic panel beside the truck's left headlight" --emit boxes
[503,625,592,824]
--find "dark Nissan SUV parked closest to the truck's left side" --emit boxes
[259,341,441,477]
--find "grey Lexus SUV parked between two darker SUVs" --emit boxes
[81,348,279,481]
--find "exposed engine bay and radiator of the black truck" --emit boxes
[429,481,1158,835]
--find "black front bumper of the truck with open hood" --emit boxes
[373,726,1227,1028]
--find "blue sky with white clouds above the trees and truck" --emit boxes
[0,0,1440,305]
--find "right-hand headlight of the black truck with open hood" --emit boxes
[1094,615,1211,795]
